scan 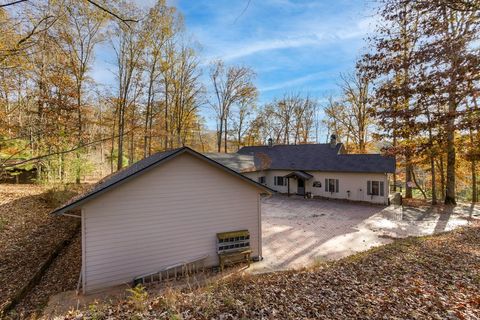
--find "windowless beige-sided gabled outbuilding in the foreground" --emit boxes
[52,147,271,293]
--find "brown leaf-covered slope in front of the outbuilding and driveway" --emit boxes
[63,222,480,319]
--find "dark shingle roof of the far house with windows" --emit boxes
[238,143,395,173]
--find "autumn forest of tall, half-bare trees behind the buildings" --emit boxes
[0,0,480,204]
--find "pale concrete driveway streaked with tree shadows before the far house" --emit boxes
[251,195,480,272]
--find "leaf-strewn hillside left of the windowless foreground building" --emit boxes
[0,184,80,319]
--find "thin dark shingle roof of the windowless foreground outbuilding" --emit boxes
[51,147,274,214]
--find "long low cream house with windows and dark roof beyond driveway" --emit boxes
[208,135,395,204]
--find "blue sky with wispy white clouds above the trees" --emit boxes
[93,0,375,130]
